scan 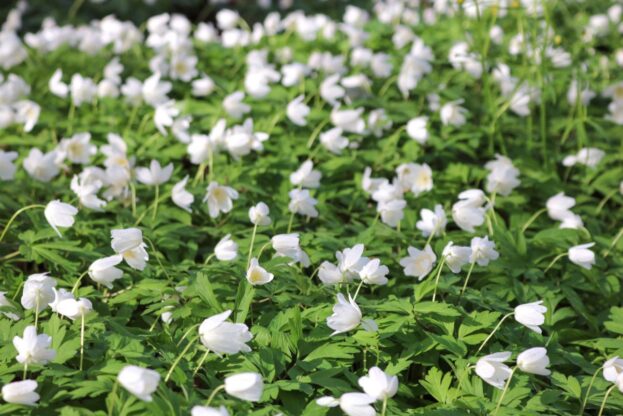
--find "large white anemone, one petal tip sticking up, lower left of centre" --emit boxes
[199,310,253,354]
